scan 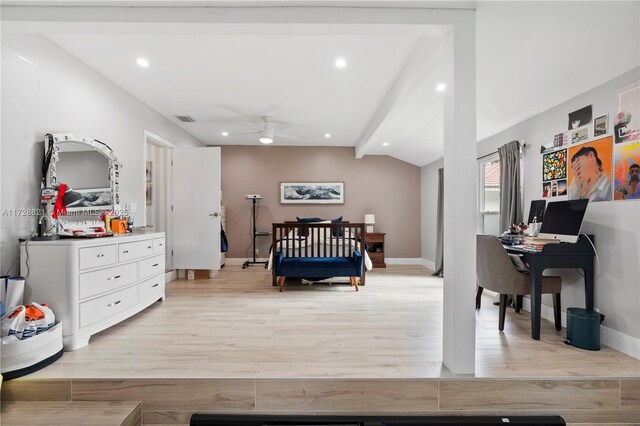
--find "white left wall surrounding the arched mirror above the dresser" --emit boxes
[0,34,203,274]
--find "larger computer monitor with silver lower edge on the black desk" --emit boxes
[538,199,589,243]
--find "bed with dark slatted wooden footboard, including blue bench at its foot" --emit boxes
[268,221,371,291]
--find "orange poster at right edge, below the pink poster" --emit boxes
[613,140,640,200]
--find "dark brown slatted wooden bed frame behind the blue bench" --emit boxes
[271,221,366,291]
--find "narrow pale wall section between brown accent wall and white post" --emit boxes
[420,159,444,269]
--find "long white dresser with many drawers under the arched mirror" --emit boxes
[20,232,165,350]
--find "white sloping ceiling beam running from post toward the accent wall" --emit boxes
[355,38,443,159]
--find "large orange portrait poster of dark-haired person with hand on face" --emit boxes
[567,136,613,201]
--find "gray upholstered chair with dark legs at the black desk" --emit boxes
[476,235,562,331]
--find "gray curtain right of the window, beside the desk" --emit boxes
[498,141,522,232]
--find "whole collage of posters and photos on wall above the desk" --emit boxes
[541,81,640,202]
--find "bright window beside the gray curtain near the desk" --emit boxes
[478,152,502,236]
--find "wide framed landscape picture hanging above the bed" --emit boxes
[280,182,344,204]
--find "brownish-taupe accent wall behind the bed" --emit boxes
[222,146,420,260]
